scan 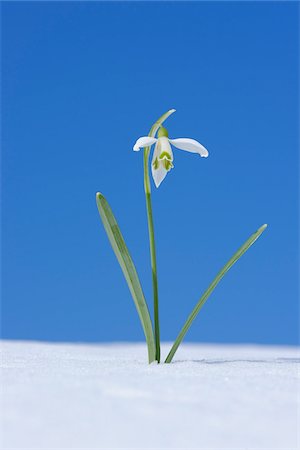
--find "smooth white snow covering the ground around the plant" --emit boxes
[1,341,300,450]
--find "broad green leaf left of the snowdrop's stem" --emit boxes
[96,192,155,363]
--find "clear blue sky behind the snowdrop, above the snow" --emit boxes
[2,2,299,344]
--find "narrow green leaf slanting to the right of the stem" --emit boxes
[165,224,267,363]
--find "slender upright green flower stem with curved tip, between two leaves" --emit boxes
[144,109,175,362]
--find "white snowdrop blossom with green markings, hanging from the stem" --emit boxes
[133,126,208,187]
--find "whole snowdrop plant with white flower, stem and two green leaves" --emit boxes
[96,109,267,363]
